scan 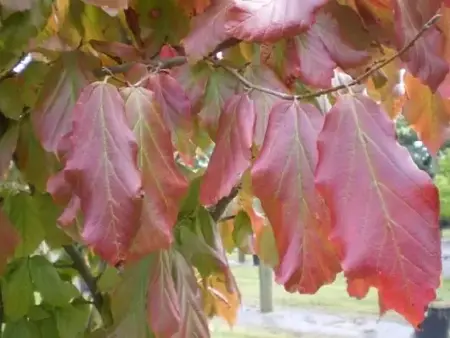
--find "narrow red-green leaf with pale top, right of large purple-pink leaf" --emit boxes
[122,87,188,260]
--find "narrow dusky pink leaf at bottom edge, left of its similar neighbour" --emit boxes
[147,251,180,338]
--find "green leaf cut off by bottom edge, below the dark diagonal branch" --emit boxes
[56,304,90,338]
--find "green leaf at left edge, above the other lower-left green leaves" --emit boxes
[4,192,45,257]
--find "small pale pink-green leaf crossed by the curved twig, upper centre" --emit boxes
[245,65,289,147]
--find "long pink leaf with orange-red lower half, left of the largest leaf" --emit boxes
[252,101,341,294]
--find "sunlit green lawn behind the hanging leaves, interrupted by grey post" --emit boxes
[232,258,450,316]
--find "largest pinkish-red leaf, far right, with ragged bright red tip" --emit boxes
[316,95,442,325]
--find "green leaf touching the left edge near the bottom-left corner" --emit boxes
[2,258,34,321]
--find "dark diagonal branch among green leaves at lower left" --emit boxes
[64,245,104,315]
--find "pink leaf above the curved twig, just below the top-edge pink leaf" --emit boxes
[286,11,369,88]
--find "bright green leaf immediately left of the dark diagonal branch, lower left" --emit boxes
[29,256,78,307]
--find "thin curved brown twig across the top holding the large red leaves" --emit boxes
[94,14,441,100]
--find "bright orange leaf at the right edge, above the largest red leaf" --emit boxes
[403,73,450,154]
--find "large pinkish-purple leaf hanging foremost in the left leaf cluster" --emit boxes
[64,82,142,264]
